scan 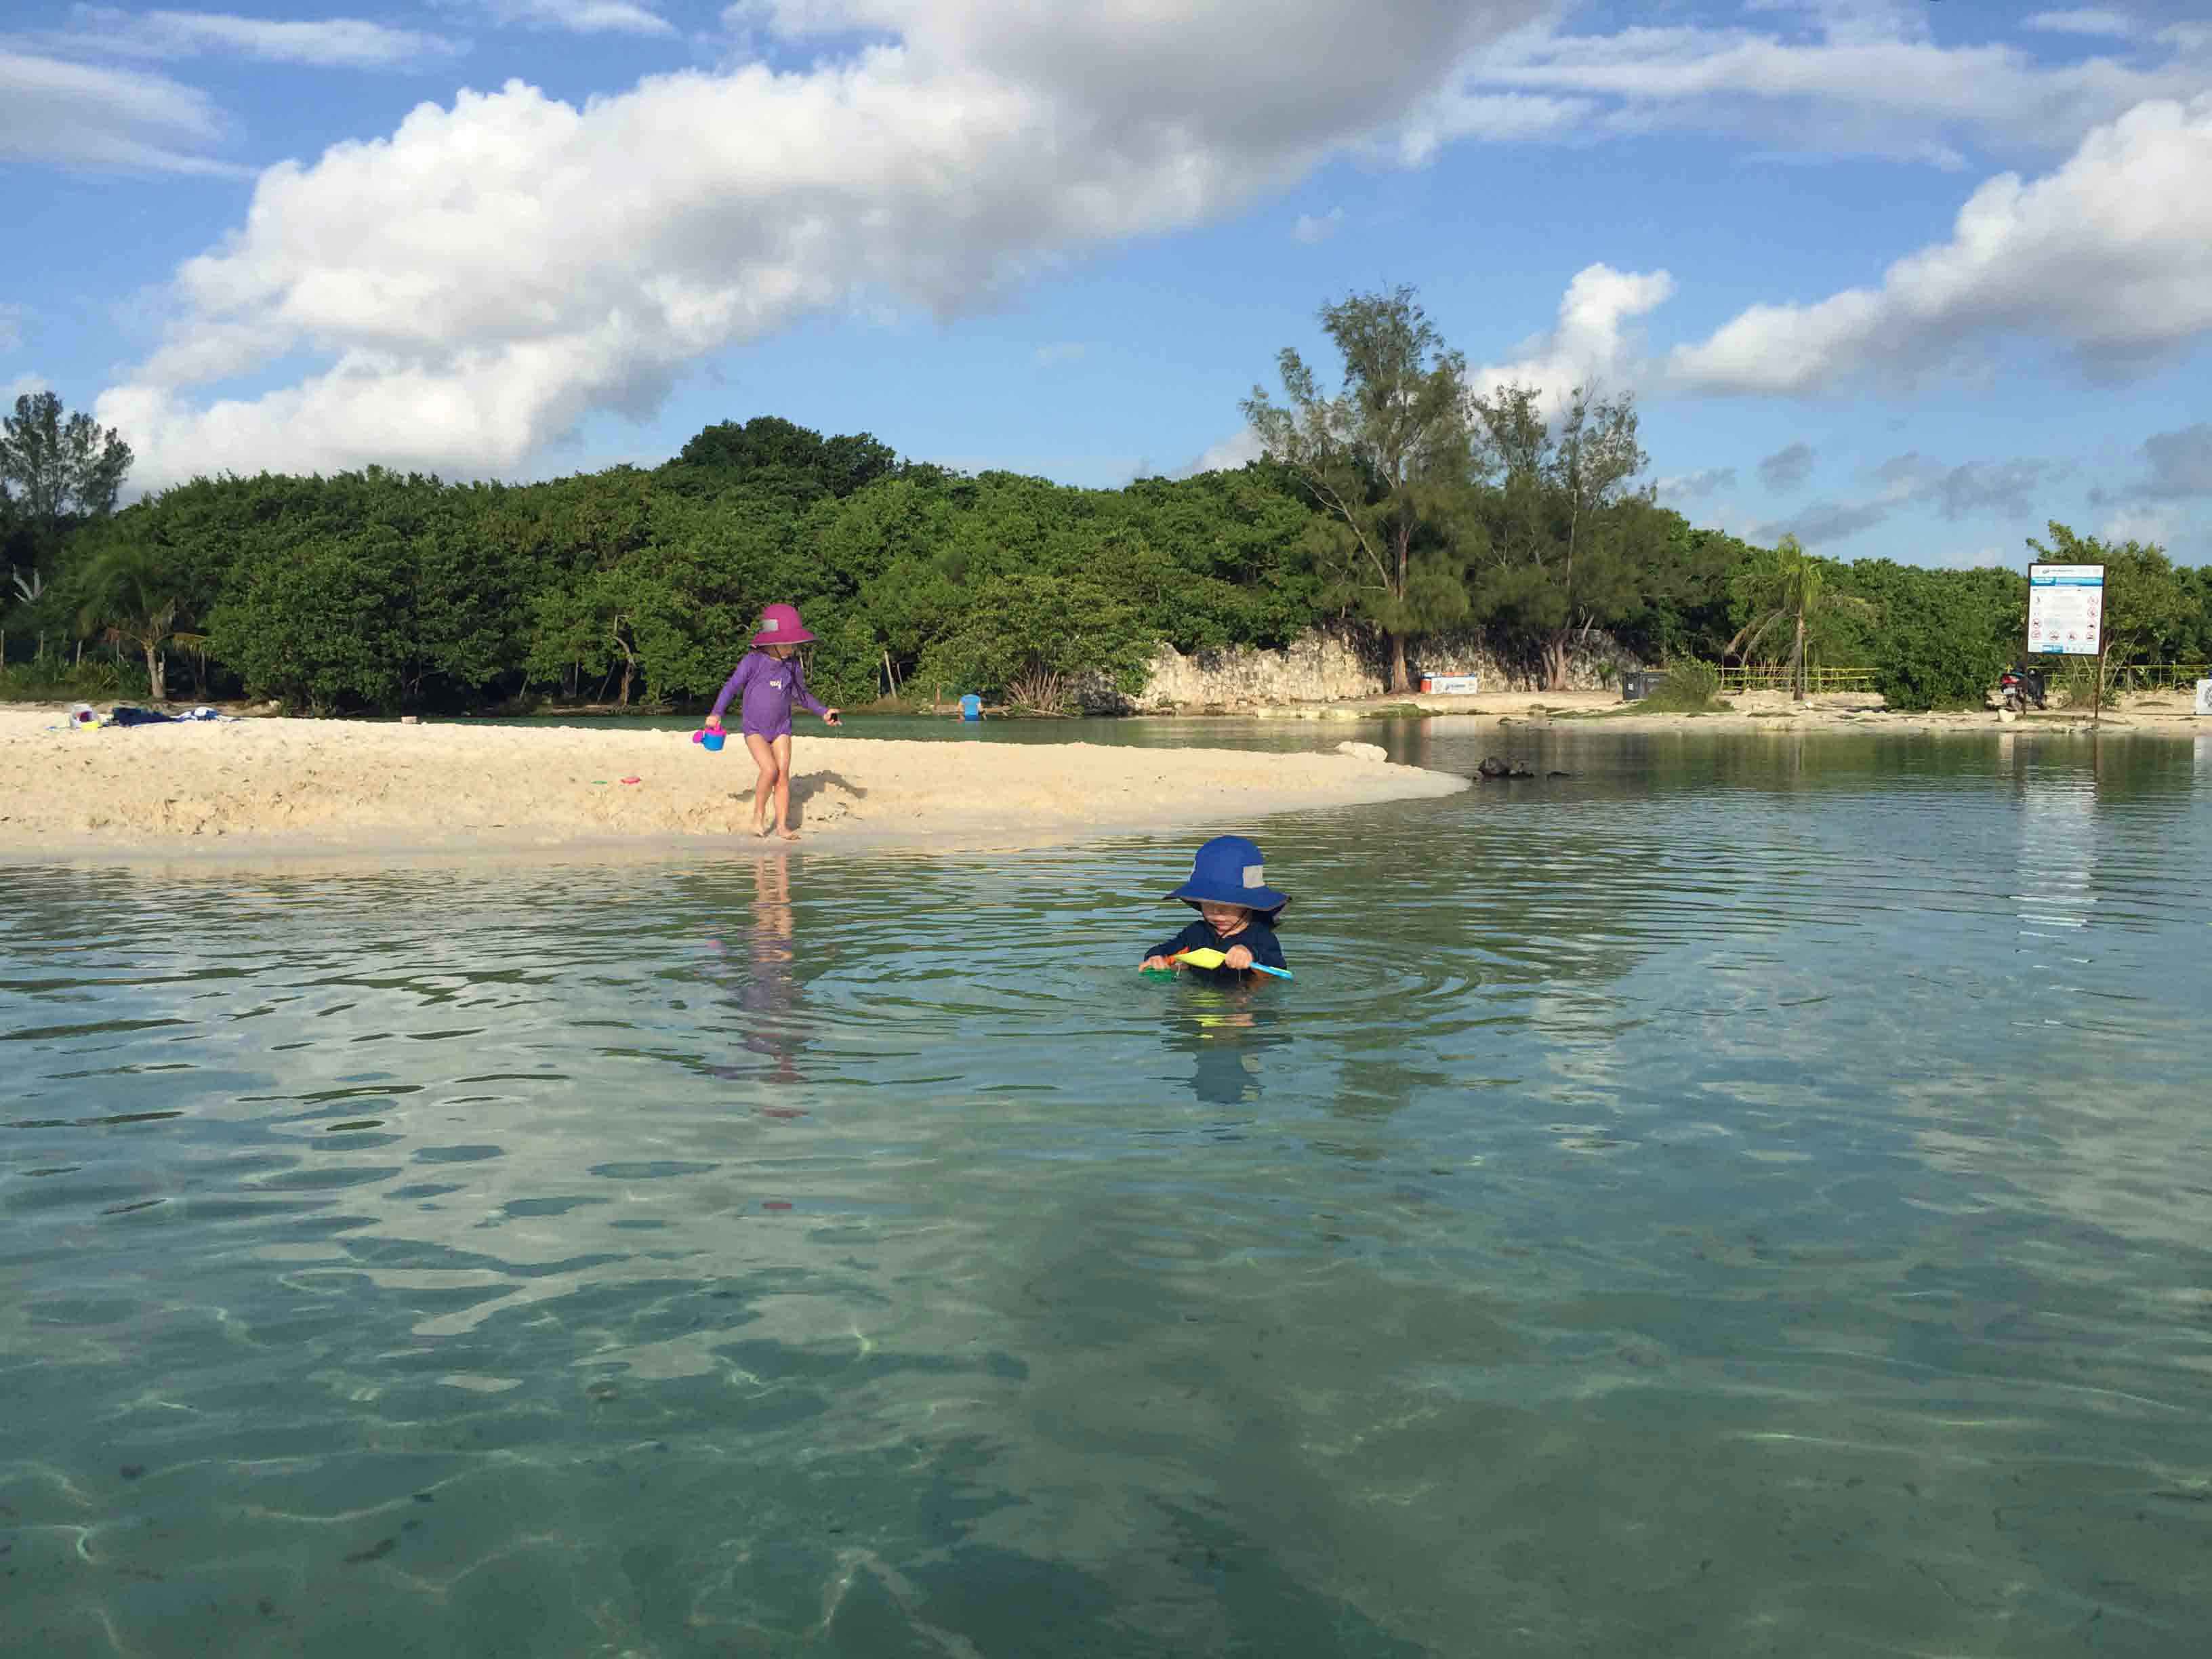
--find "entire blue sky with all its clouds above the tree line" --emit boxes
[0,0,2212,564]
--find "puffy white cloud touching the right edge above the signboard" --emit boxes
[1670,95,2212,394]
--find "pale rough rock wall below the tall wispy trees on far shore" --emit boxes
[1097,628,1643,714]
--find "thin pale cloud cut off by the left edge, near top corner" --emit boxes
[0,49,243,173]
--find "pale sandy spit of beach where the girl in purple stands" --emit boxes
[0,710,1467,861]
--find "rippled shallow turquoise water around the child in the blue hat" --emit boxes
[0,721,2212,1659]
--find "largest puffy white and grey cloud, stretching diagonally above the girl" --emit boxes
[98,0,1542,485]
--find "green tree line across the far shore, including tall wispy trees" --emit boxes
[0,290,2212,712]
